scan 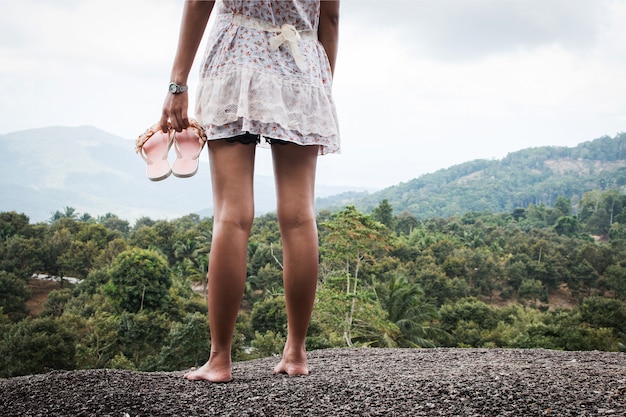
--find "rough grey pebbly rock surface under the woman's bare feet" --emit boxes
[0,349,626,417]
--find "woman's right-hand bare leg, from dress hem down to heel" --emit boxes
[272,144,318,375]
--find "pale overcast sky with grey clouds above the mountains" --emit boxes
[0,0,626,189]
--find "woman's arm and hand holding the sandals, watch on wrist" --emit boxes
[160,0,215,132]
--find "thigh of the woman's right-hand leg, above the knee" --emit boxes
[272,143,319,220]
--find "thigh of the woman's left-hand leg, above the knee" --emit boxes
[208,140,256,222]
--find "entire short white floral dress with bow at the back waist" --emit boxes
[196,0,340,155]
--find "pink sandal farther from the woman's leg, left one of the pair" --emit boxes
[136,123,172,181]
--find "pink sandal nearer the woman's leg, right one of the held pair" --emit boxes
[172,119,207,178]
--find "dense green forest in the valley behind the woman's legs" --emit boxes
[0,189,626,377]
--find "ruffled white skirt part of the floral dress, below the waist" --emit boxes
[196,16,340,155]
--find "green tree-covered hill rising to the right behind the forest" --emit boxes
[318,133,626,219]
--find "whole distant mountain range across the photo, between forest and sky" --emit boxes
[0,126,626,222]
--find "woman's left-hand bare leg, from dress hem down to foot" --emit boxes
[185,140,256,382]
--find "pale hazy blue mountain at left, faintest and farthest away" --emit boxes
[0,126,366,222]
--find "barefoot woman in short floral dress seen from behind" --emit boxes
[160,0,339,382]
